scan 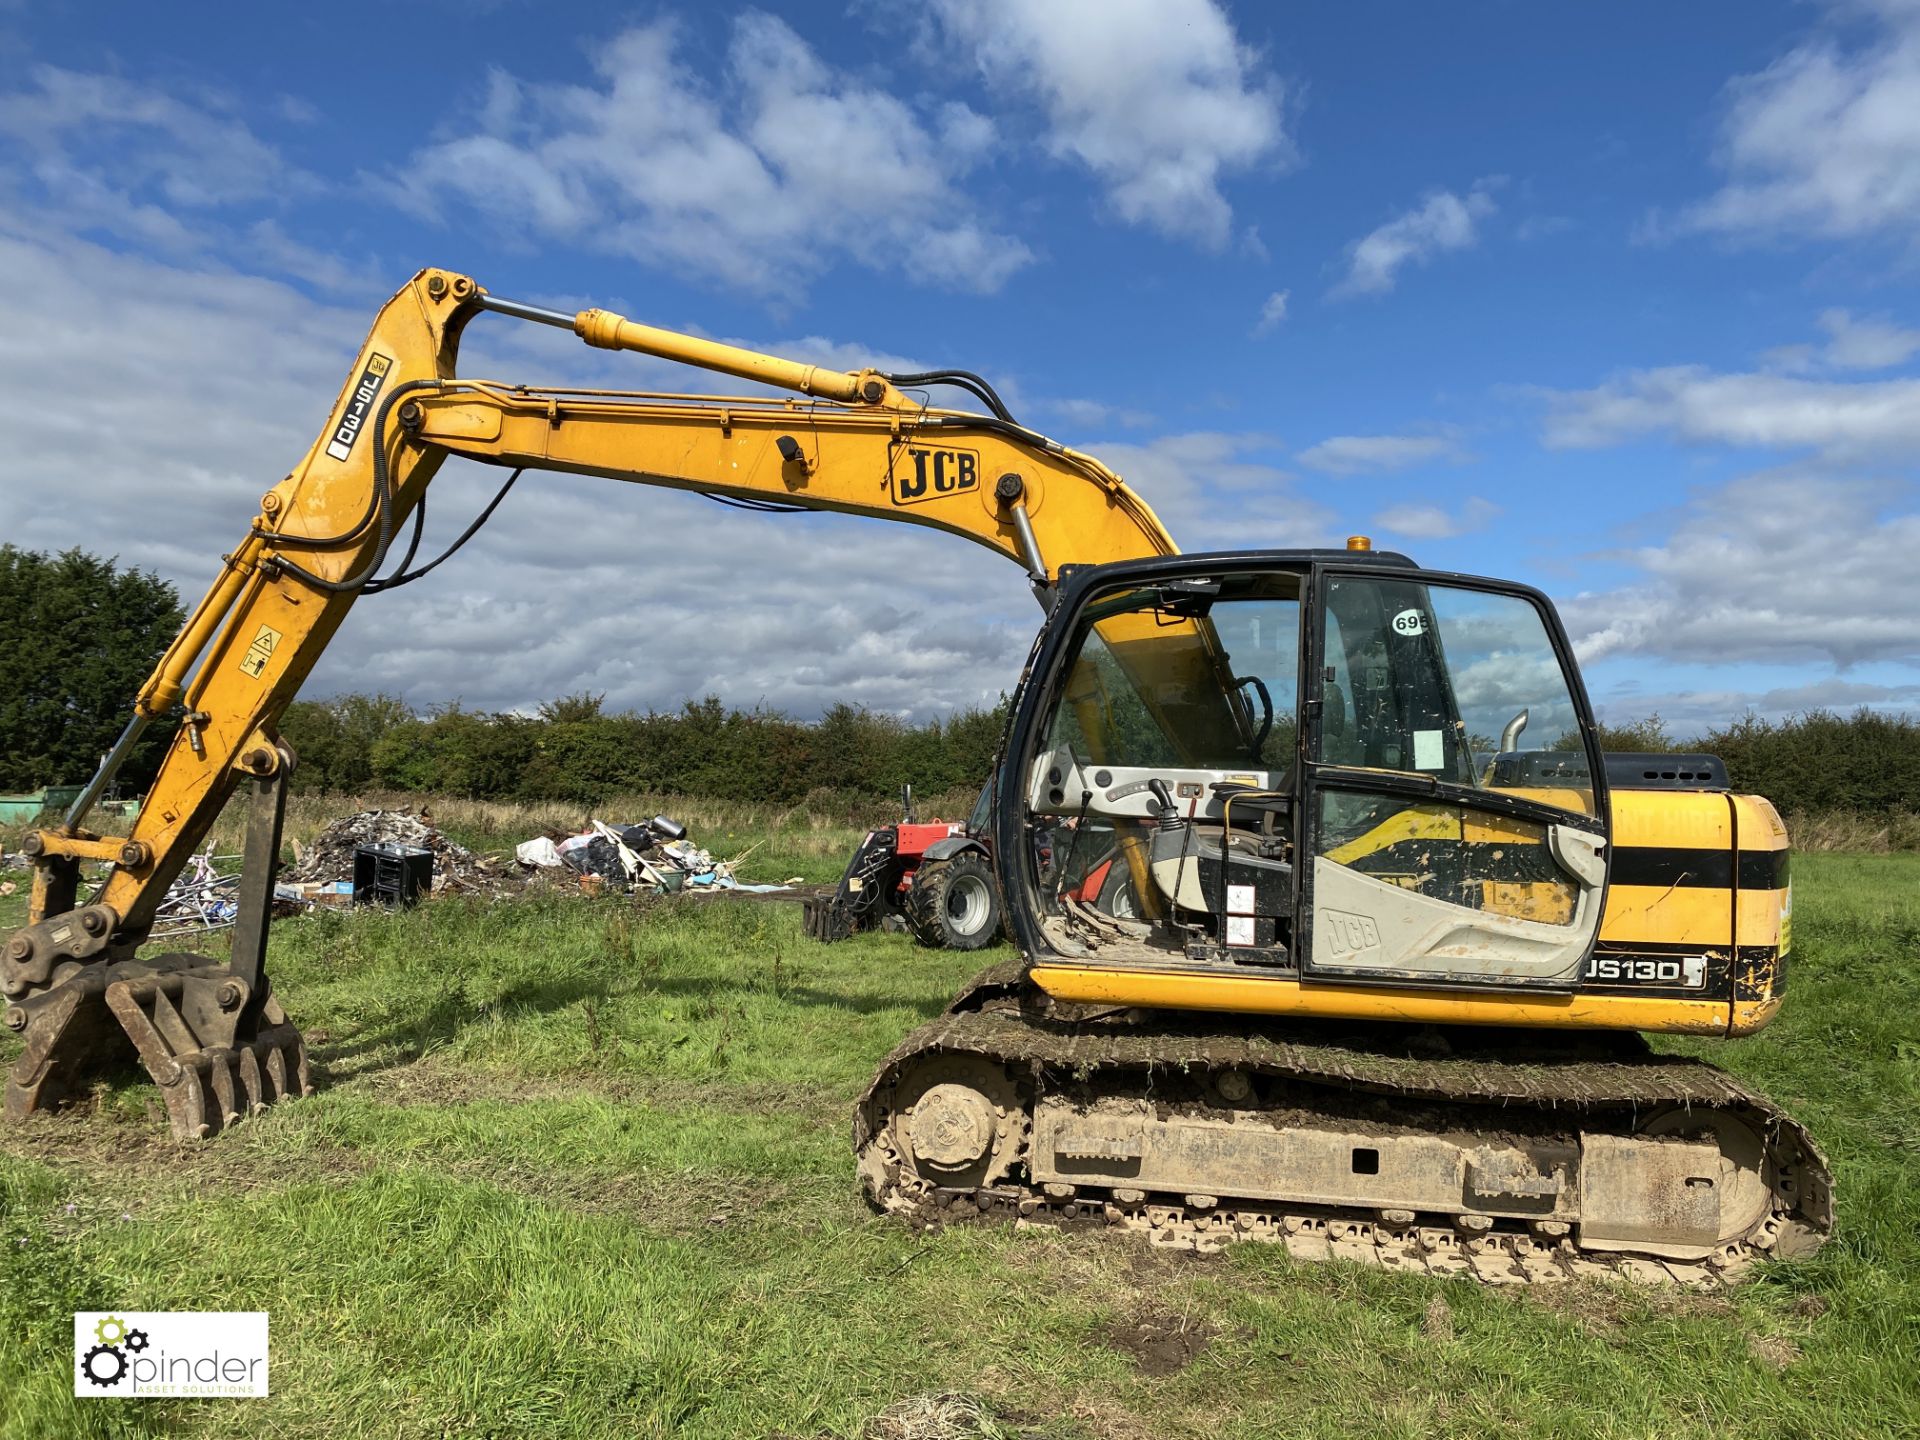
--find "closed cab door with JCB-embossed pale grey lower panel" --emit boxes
[1296,566,1609,989]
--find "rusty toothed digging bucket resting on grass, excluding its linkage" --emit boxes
[6,954,313,1140]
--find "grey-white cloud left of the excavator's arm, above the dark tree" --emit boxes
[0,217,372,579]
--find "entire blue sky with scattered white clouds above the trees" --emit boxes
[0,0,1920,737]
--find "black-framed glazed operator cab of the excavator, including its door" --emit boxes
[995,551,1609,989]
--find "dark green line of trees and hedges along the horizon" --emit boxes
[0,545,1920,816]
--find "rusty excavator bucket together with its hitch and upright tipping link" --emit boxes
[0,755,313,1140]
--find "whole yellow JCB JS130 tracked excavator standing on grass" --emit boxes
[0,269,1832,1283]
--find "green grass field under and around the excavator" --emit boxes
[0,808,1920,1440]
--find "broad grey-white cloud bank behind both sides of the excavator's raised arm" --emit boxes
[0,217,1039,716]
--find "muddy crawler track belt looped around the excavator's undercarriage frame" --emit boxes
[852,962,1834,1283]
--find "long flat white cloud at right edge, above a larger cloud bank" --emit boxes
[1544,365,1920,455]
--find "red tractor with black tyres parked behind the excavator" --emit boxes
[806,785,1002,950]
